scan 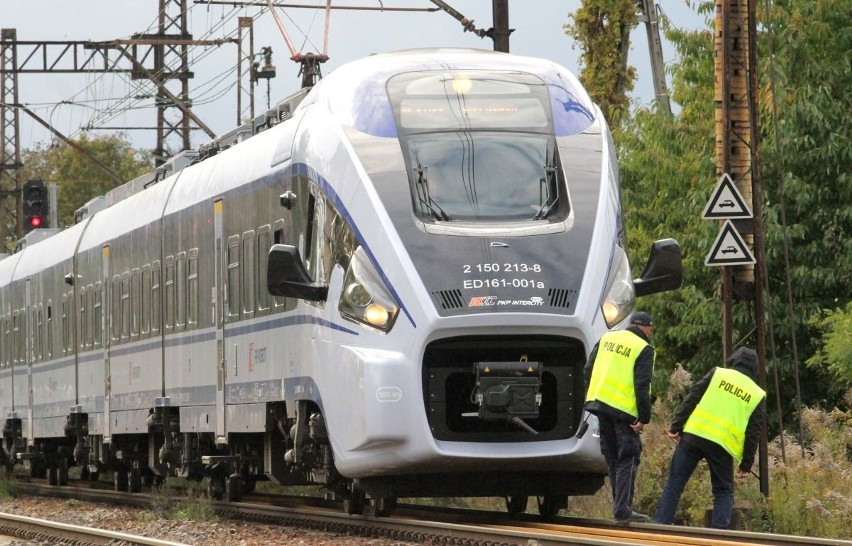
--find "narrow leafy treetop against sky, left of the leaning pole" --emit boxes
[564,0,637,123]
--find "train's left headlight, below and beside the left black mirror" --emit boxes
[338,247,399,332]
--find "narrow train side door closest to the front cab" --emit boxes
[213,199,228,444]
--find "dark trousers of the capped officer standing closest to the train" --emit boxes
[598,413,642,519]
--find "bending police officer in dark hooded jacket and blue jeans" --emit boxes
[654,347,766,529]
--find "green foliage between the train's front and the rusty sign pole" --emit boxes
[615,17,747,376]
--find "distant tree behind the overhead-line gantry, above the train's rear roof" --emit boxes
[22,135,151,227]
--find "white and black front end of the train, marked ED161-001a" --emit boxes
[270,50,679,500]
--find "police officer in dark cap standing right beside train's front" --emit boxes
[584,311,654,523]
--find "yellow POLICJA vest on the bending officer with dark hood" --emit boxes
[683,368,766,463]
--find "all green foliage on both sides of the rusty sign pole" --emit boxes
[600,0,852,410]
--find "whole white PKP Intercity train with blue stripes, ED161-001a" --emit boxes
[0,49,681,515]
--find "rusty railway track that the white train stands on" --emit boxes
[8,483,852,546]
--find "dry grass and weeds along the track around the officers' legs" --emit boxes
[624,369,852,540]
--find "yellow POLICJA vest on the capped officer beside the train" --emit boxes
[586,330,648,419]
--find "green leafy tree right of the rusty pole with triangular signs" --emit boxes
[760,0,852,407]
